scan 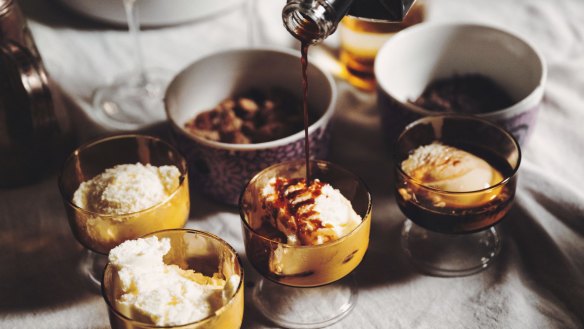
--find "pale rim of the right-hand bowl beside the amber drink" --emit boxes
[373,21,548,119]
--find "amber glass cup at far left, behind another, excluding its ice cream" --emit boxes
[59,135,190,285]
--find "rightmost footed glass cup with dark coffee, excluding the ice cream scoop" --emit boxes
[395,115,521,277]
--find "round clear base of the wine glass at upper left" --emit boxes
[93,70,171,130]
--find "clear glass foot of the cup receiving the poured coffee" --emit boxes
[253,275,358,328]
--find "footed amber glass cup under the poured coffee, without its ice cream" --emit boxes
[239,160,371,328]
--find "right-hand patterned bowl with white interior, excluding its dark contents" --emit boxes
[374,22,547,146]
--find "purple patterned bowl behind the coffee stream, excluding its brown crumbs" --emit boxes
[164,48,337,205]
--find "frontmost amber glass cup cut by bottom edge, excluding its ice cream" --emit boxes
[101,229,244,329]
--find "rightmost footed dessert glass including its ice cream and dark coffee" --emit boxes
[395,115,521,277]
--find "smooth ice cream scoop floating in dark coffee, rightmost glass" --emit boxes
[401,142,503,192]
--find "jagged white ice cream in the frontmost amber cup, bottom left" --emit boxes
[109,237,241,326]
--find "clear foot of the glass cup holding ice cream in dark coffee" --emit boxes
[401,219,501,277]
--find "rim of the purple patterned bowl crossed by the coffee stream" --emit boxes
[164,47,338,151]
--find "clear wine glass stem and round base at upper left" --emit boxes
[93,0,171,130]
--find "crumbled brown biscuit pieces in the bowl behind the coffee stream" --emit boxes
[185,89,312,144]
